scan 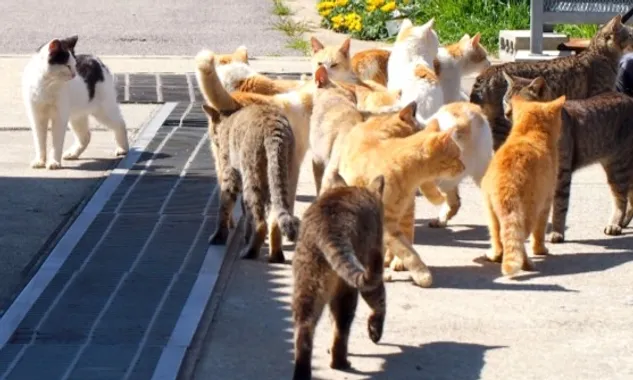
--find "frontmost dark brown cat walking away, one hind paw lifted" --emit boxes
[292,174,386,380]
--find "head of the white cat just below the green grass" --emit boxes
[394,18,440,62]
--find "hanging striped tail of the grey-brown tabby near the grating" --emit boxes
[264,116,300,242]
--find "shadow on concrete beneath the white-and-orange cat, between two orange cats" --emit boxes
[414,219,490,249]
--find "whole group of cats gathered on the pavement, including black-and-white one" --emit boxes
[23,10,633,380]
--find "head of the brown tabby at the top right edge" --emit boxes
[588,15,633,55]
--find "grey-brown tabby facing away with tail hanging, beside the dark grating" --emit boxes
[202,104,299,263]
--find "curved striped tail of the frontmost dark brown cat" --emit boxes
[320,243,384,292]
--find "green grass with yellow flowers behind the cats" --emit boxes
[317,0,597,53]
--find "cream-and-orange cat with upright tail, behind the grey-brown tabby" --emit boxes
[195,49,314,256]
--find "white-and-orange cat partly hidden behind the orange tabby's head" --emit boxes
[420,102,493,227]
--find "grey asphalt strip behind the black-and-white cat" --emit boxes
[0,0,300,56]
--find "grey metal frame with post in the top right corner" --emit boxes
[530,0,633,55]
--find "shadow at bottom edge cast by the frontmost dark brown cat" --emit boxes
[326,341,505,380]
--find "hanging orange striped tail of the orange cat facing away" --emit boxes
[499,210,527,276]
